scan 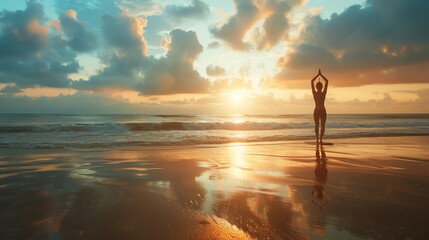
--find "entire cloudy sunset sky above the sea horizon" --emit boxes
[0,0,429,114]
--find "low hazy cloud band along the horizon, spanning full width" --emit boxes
[0,86,429,114]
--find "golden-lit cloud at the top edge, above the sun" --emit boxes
[210,0,302,51]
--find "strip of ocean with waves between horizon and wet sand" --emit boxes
[0,114,429,149]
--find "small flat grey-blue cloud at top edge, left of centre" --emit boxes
[165,0,210,20]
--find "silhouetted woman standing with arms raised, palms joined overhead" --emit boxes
[311,69,328,143]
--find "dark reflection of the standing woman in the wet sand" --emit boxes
[311,145,329,210]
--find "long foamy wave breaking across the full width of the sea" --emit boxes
[0,121,429,134]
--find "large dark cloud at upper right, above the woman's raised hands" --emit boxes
[279,0,429,85]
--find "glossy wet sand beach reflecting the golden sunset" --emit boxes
[0,137,429,239]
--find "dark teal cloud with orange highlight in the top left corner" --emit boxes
[0,1,80,88]
